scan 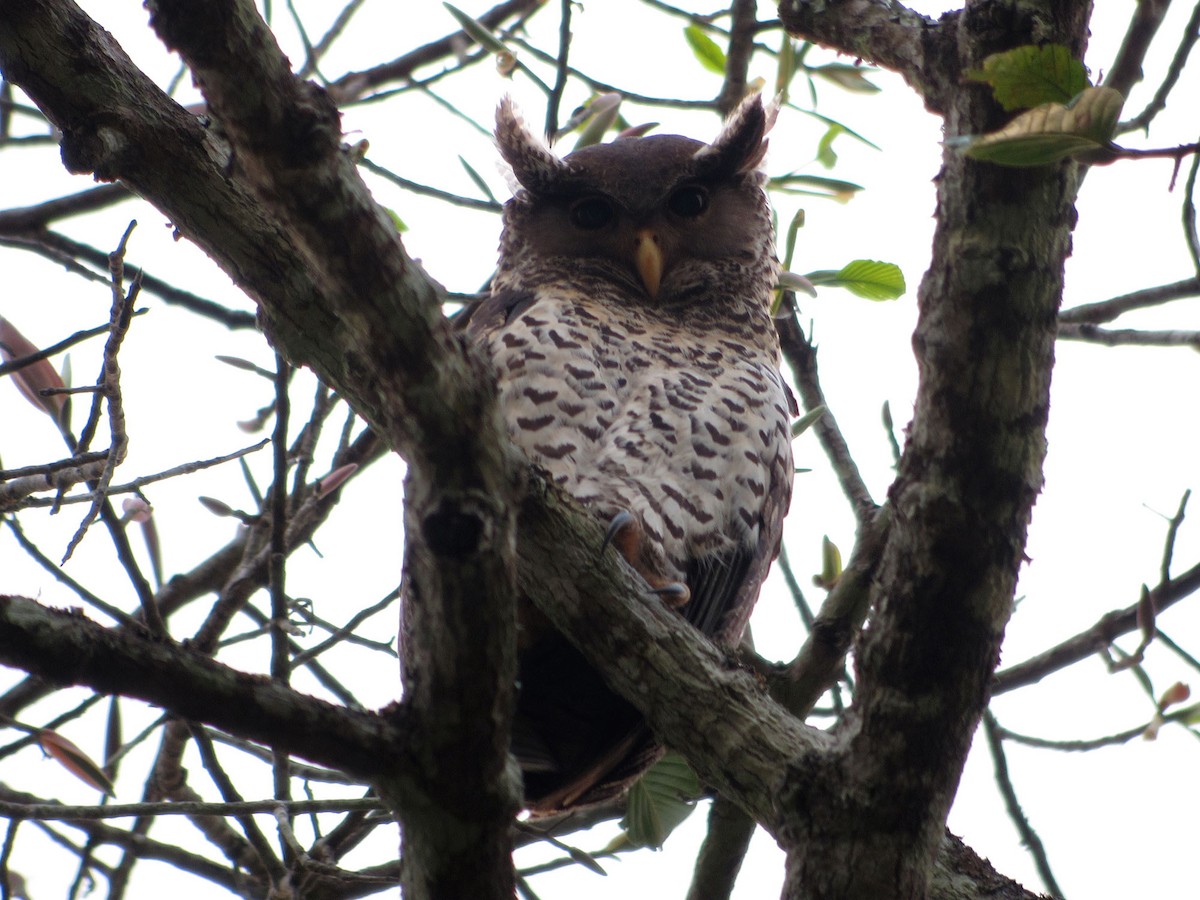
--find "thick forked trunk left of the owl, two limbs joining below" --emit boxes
[0,0,520,900]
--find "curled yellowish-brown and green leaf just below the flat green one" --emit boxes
[960,88,1124,167]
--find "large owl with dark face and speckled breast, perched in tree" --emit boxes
[466,96,796,812]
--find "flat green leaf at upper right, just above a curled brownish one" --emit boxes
[967,43,1090,110]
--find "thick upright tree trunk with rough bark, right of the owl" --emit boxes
[780,1,1090,898]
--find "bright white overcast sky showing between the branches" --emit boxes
[0,0,1200,900]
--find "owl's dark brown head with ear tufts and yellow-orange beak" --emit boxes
[496,95,775,305]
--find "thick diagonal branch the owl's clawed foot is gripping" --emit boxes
[517,481,829,830]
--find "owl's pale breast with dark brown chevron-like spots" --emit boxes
[487,292,792,580]
